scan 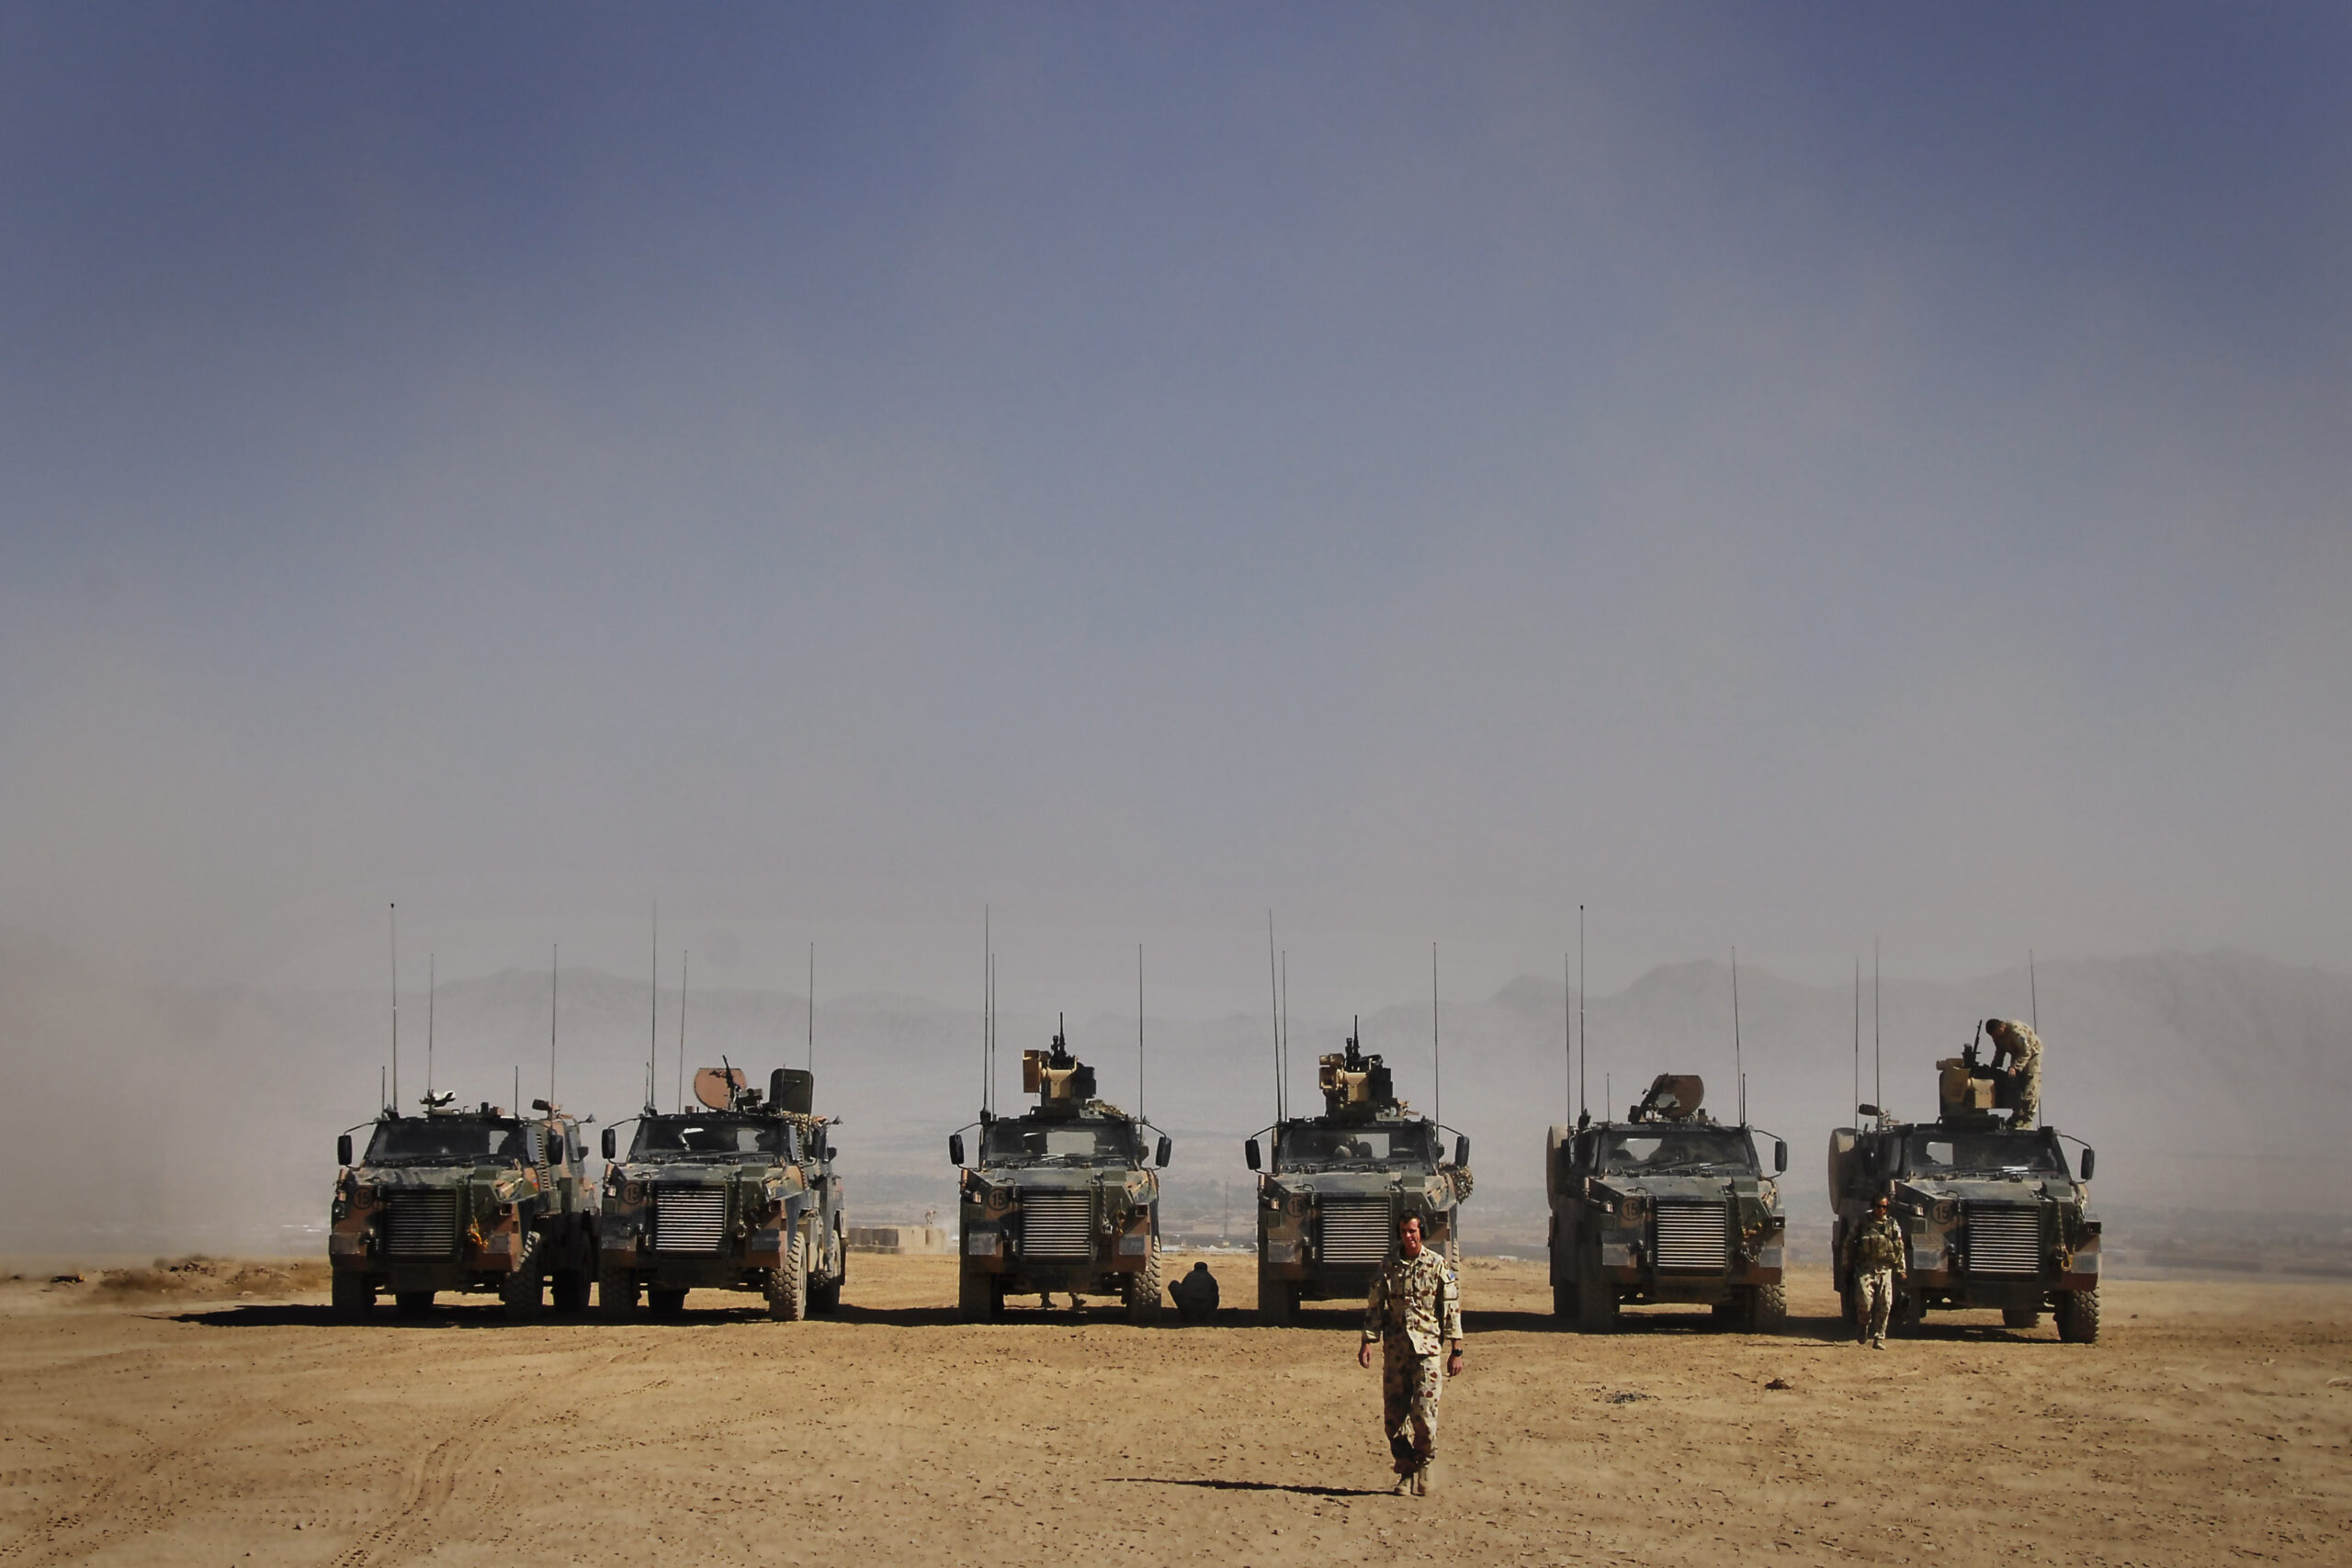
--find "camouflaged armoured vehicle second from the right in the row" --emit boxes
[1543,1072,1788,1333]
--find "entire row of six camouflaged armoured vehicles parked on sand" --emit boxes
[329,1034,2100,1340]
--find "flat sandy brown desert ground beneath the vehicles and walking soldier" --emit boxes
[0,1256,2352,1568]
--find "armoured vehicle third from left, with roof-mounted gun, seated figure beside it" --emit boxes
[948,1032,1169,1324]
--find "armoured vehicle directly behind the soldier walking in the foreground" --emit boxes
[1242,1034,1473,1324]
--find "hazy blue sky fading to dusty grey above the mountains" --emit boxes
[0,0,2352,1009]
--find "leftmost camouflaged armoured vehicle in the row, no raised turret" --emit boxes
[327,1093,597,1319]
